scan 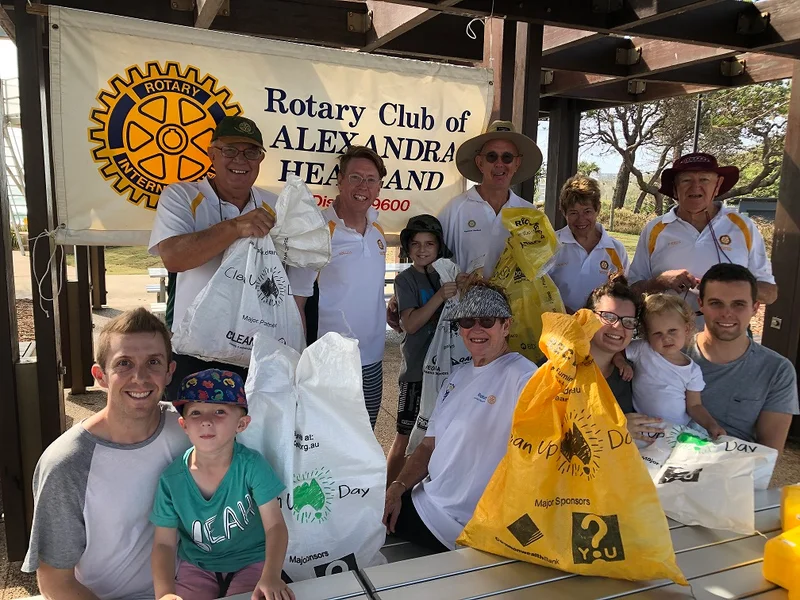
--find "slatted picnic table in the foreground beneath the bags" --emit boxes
[227,489,788,600]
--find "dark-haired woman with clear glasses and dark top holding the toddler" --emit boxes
[586,275,661,441]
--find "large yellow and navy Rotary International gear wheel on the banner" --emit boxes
[89,61,242,210]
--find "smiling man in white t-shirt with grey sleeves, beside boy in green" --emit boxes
[22,308,189,600]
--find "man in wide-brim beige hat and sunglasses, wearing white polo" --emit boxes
[439,121,542,278]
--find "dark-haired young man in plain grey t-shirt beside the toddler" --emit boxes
[687,263,799,452]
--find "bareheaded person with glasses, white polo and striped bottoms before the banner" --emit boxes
[317,146,386,428]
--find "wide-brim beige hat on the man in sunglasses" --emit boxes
[456,121,542,184]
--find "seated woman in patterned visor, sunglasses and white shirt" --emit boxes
[383,281,536,551]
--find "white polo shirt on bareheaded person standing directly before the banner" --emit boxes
[317,205,386,366]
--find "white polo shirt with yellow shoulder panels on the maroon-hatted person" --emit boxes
[630,205,775,327]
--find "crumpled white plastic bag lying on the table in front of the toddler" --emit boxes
[654,432,755,534]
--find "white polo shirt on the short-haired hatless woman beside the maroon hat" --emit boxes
[549,223,629,312]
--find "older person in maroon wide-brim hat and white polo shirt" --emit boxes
[630,152,778,329]
